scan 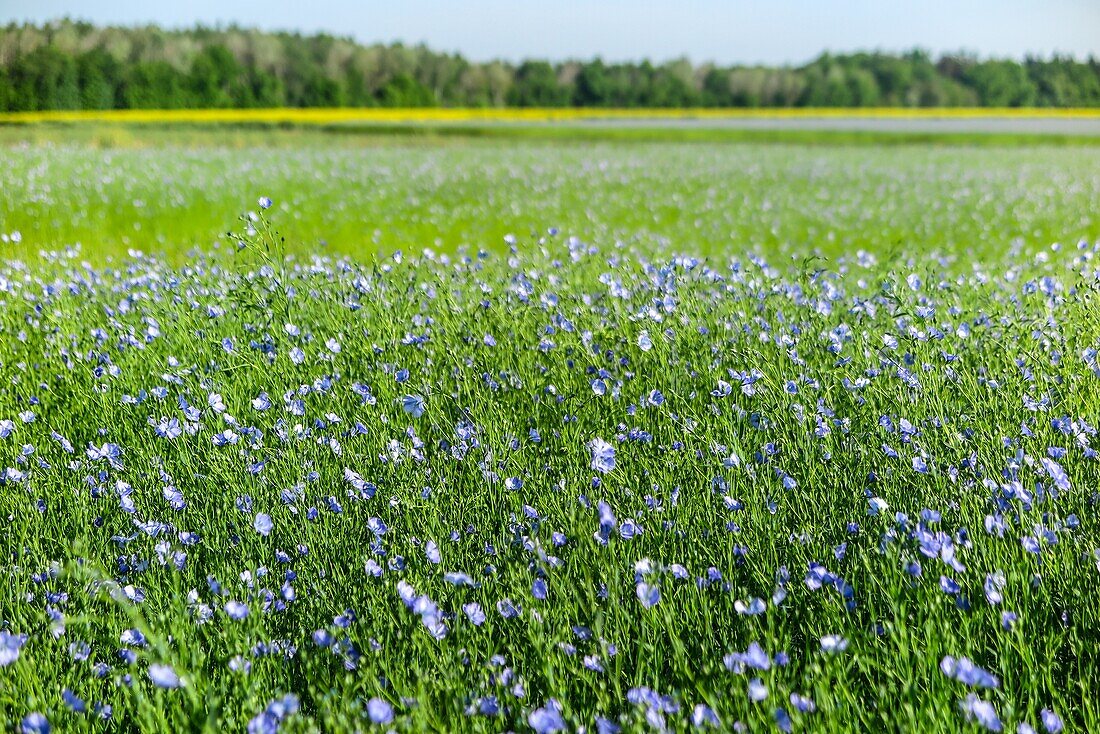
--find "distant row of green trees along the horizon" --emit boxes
[0,20,1100,111]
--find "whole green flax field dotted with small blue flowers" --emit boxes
[0,123,1100,734]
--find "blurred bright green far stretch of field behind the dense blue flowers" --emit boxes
[0,130,1100,267]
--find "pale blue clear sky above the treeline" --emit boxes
[0,0,1100,64]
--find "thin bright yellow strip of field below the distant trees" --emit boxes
[0,107,1100,124]
